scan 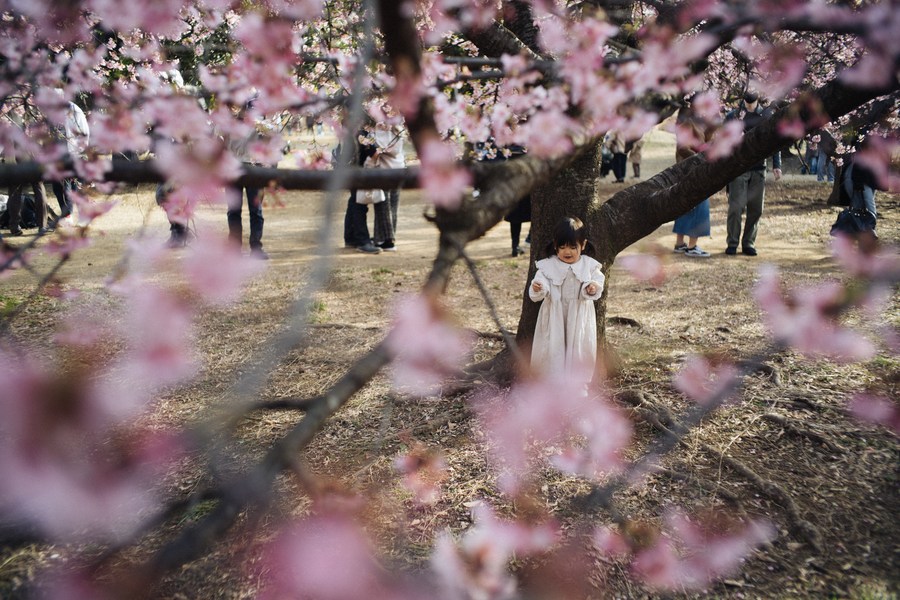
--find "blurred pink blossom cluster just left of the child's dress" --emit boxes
[386,296,472,396]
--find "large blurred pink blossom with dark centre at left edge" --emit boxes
[0,346,180,540]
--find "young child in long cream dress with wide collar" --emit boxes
[528,217,606,383]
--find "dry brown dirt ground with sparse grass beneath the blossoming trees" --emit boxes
[0,132,900,598]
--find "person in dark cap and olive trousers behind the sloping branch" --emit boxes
[725,91,781,256]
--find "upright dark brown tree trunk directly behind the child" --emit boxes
[516,143,615,356]
